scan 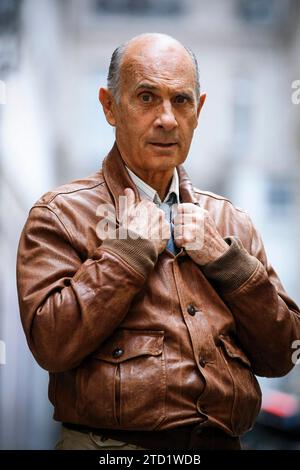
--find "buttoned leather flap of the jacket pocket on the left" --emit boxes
[92,329,164,364]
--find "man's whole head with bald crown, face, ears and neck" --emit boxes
[99,34,206,189]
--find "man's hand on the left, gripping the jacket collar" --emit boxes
[121,188,171,254]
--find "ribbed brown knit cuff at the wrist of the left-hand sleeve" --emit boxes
[101,230,158,277]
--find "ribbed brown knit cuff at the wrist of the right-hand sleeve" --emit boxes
[201,237,259,294]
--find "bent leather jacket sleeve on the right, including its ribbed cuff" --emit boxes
[203,216,300,377]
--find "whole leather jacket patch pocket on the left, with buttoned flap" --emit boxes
[77,329,166,430]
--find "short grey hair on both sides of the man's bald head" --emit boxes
[107,41,200,102]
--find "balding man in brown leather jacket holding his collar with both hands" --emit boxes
[17,34,300,449]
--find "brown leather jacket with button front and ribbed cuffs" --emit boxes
[17,144,300,435]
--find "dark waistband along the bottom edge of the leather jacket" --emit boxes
[63,423,241,450]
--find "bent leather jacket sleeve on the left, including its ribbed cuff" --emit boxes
[17,206,157,372]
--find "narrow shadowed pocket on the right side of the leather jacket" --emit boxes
[219,335,261,435]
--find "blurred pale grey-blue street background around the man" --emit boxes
[0,0,300,449]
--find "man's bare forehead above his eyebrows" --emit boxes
[121,47,195,89]
